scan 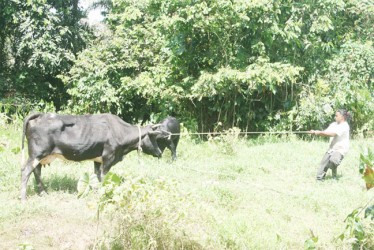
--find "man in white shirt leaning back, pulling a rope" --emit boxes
[309,109,350,181]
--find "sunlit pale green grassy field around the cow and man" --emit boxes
[0,124,374,249]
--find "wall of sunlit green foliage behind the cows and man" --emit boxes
[0,0,374,132]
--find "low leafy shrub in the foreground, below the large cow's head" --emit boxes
[93,173,202,249]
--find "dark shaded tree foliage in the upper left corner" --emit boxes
[0,0,92,111]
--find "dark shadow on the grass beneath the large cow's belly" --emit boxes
[34,175,78,194]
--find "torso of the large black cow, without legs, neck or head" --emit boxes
[26,113,120,161]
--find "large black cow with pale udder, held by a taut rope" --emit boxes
[21,113,162,200]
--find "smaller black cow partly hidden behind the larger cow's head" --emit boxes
[141,117,180,161]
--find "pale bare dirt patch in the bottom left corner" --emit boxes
[0,193,100,249]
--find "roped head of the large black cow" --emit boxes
[141,125,163,158]
